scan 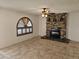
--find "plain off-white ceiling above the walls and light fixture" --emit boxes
[0,0,79,14]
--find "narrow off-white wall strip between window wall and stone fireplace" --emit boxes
[39,16,46,36]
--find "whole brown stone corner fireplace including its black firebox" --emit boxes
[46,13,68,39]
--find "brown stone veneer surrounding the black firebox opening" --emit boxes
[46,13,67,37]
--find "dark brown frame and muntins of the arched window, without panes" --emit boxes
[16,17,33,36]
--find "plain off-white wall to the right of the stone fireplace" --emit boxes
[67,12,79,41]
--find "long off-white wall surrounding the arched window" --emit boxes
[0,8,39,48]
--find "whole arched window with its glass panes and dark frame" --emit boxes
[17,17,33,36]
